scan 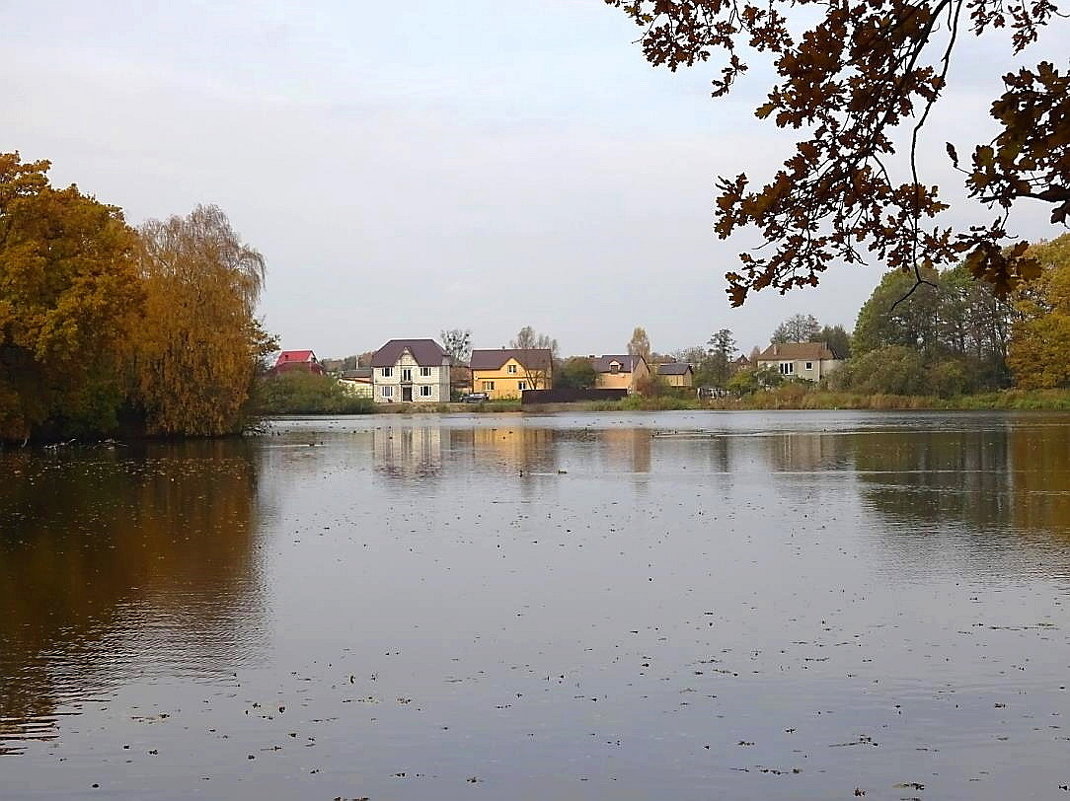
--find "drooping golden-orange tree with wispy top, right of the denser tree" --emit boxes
[135,205,264,436]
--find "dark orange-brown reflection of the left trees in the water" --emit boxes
[0,442,260,738]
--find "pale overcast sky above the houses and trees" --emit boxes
[6,0,1066,357]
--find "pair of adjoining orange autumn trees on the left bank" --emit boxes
[0,153,275,442]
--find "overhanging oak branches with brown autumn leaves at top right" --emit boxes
[606,0,1070,306]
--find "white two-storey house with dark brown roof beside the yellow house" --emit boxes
[371,339,449,403]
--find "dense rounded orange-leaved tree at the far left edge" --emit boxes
[0,153,142,440]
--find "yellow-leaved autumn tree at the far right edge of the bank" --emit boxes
[1007,234,1070,389]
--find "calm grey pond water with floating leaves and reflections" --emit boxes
[0,412,1070,801]
